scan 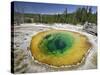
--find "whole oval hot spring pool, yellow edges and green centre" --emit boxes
[30,29,92,67]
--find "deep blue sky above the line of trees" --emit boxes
[14,1,97,14]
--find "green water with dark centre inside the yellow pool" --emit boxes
[39,32,74,55]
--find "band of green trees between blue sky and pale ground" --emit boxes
[14,7,97,25]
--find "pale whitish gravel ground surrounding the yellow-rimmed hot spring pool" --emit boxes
[14,23,97,73]
